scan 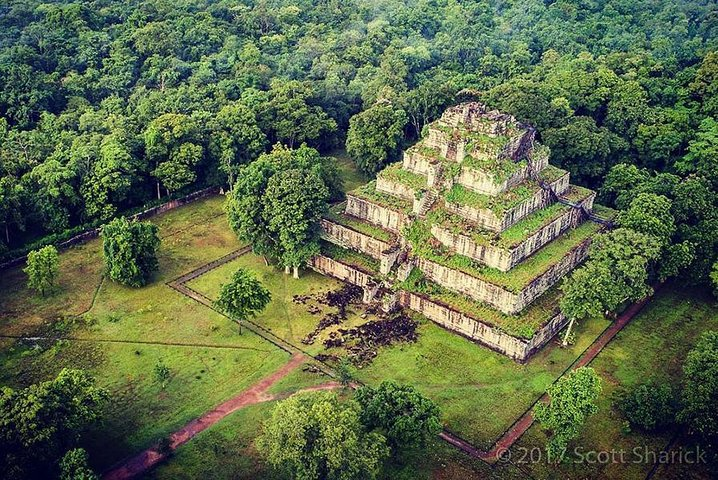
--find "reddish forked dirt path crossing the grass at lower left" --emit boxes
[102,355,340,480]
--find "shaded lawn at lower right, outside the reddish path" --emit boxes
[512,285,718,479]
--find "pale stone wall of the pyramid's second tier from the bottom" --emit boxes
[417,239,591,315]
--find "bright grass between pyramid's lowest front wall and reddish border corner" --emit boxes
[357,319,608,448]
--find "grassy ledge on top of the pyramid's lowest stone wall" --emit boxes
[400,268,560,339]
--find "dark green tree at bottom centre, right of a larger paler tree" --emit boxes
[356,381,441,450]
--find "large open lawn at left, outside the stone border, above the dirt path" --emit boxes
[0,197,310,469]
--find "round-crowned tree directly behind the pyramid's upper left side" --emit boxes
[346,100,408,175]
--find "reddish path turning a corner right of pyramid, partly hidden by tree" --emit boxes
[439,284,663,463]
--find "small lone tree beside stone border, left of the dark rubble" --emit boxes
[215,268,272,321]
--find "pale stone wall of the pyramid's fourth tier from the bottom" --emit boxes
[446,172,570,232]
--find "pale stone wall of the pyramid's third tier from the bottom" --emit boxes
[431,193,596,272]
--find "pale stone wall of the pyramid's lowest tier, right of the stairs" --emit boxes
[398,290,566,362]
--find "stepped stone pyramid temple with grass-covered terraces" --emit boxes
[311,102,610,362]
